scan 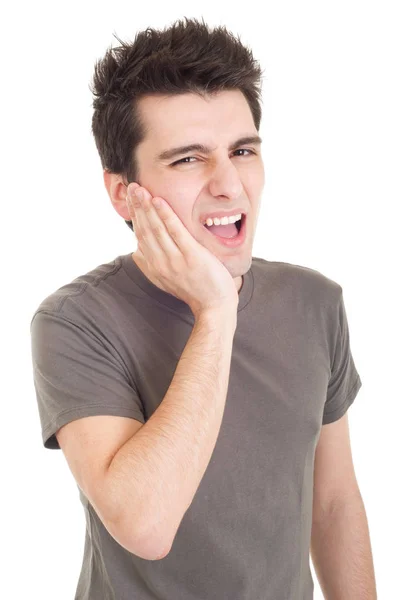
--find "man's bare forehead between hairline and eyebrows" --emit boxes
[138,90,256,149]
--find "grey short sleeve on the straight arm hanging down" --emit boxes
[322,290,362,425]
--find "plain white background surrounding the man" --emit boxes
[0,0,398,600]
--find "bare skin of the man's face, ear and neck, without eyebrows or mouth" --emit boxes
[104,90,265,292]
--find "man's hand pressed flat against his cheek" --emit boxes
[127,183,239,318]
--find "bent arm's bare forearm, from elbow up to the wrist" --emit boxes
[107,306,237,558]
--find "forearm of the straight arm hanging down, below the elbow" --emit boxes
[311,492,377,600]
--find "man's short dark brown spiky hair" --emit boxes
[89,17,262,231]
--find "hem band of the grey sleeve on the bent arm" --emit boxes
[42,404,145,450]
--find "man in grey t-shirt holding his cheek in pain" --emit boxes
[31,20,376,600]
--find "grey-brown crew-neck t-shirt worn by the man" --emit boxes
[31,253,362,600]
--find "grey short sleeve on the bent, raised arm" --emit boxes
[30,311,145,450]
